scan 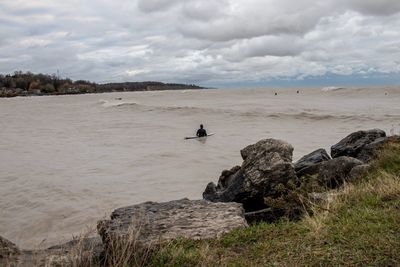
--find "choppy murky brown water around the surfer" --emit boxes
[0,88,400,248]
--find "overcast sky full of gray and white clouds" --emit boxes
[0,0,400,87]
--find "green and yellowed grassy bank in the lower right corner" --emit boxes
[151,143,400,266]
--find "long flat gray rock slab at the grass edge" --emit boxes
[97,199,247,250]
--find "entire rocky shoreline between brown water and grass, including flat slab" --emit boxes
[0,129,400,266]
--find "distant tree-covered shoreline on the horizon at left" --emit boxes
[0,71,203,97]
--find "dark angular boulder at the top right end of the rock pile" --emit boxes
[331,129,386,161]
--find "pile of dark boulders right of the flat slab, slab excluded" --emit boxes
[203,129,387,221]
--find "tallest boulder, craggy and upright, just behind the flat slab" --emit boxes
[203,139,297,212]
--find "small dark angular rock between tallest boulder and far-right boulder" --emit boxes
[294,148,331,177]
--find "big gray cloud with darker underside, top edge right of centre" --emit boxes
[178,0,330,41]
